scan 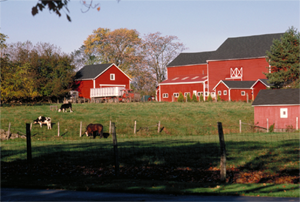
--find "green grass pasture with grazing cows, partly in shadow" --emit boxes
[0,102,300,196]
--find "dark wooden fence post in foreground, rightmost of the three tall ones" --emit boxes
[218,122,226,182]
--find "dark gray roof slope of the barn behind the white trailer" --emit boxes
[75,63,112,80]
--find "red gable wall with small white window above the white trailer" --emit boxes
[95,65,130,89]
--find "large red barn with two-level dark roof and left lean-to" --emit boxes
[157,34,282,101]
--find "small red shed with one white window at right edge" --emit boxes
[252,89,300,131]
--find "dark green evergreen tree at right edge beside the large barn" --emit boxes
[265,27,300,88]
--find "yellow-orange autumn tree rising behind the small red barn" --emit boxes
[84,28,141,74]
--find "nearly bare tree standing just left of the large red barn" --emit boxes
[142,32,185,84]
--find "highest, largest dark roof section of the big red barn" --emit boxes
[208,33,283,60]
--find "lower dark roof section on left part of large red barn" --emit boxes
[167,51,214,67]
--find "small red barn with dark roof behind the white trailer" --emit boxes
[74,63,131,99]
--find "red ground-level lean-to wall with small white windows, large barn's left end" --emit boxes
[160,83,203,102]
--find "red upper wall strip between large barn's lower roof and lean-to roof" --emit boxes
[167,64,207,78]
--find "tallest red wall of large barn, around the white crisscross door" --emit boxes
[208,58,269,91]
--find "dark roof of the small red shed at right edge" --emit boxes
[252,89,300,106]
